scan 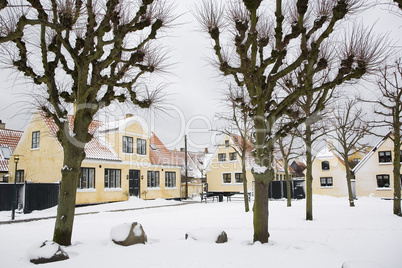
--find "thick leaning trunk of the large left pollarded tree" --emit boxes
[53,143,85,246]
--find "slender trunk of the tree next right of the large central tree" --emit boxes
[305,124,313,221]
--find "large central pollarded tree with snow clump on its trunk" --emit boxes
[196,0,383,243]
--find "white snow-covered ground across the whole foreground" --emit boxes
[0,196,402,268]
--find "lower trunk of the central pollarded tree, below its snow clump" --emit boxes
[253,177,269,243]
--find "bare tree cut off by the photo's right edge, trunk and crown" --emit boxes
[369,58,402,216]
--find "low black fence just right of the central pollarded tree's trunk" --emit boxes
[268,180,306,199]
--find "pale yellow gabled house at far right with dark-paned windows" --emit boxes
[353,134,402,198]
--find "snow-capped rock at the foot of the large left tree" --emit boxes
[28,240,69,264]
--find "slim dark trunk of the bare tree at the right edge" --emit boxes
[393,122,402,217]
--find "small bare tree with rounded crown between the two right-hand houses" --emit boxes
[328,100,372,207]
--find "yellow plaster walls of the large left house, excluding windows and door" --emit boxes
[9,113,180,204]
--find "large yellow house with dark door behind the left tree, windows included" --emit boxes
[9,112,180,204]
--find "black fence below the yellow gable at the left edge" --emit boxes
[0,182,60,213]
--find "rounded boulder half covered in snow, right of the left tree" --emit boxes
[110,222,148,246]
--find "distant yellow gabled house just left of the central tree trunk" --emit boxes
[206,135,254,193]
